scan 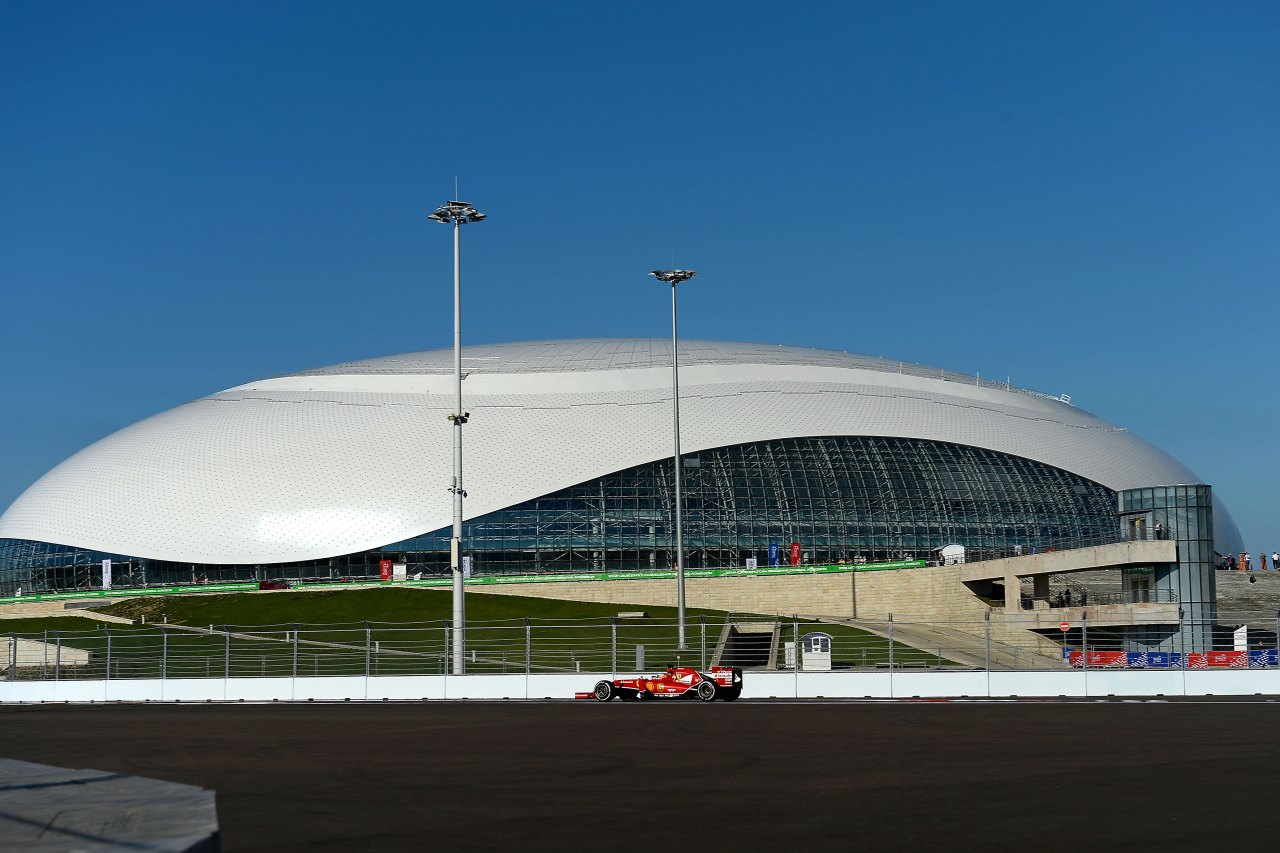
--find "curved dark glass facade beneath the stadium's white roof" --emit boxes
[0,435,1121,594]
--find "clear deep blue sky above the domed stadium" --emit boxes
[0,0,1280,552]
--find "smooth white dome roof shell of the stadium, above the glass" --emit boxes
[0,338,1238,565]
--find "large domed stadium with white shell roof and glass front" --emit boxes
[0,339,1240,601]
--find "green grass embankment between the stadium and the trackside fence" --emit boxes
[0,588,957,678]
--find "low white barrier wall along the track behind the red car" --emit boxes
[0,670,1280,703]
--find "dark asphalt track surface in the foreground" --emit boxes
[0,702,1280,853]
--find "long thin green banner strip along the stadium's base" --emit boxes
[0,560,925,605]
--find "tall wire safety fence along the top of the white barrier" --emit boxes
[10,606,1280,681]
